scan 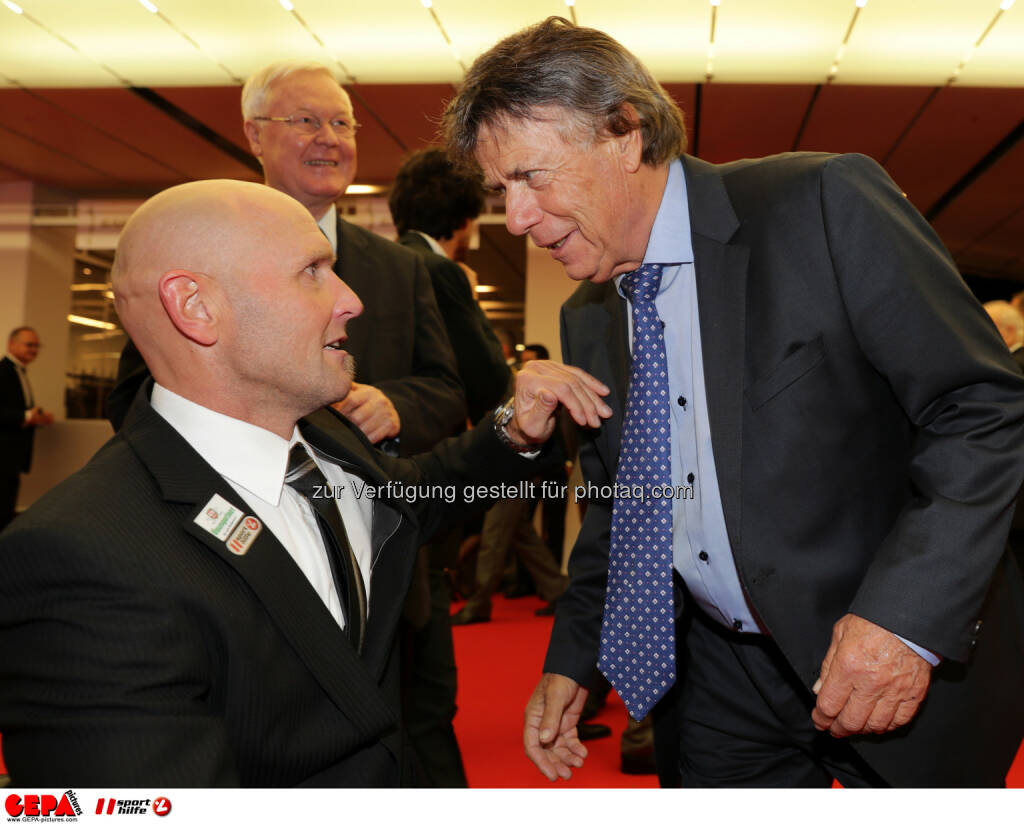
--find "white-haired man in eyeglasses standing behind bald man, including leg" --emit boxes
[242,61,466,787]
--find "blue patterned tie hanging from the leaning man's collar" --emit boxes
[598,264,676,721]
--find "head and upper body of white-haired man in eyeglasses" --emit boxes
[242,61,466,454]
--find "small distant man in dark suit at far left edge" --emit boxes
[0,327,53,529]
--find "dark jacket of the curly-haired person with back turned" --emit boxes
[398,231,512,422]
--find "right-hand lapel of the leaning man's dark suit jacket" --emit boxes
[683,157,750,553]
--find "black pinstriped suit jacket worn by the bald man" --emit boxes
[0,387,535,786]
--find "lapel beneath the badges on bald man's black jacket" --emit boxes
[122,391,392,733]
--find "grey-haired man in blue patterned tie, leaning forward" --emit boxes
[444,18,1024,786]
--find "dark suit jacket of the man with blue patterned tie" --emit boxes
[546,154,1024,785]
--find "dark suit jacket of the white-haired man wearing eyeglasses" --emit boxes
[106,218,466,456]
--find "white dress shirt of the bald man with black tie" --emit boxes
[152,384,373,627]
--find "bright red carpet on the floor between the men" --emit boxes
[453,596,1024,788]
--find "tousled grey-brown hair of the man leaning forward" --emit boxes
[441,17,686,166]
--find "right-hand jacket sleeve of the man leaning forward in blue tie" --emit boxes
[820,155,1024,660]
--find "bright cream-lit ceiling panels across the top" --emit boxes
[0,0,1024,88]
